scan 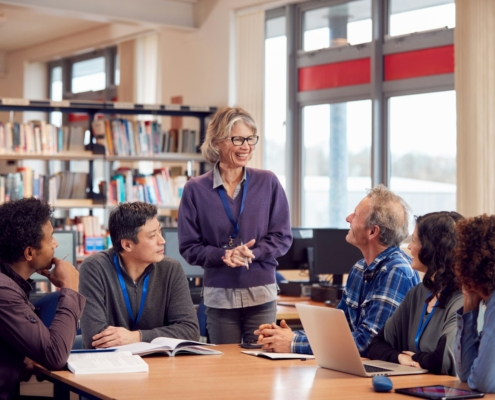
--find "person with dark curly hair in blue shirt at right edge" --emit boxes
[455,214,495,393]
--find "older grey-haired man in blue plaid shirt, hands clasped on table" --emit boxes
[255,185,419,357]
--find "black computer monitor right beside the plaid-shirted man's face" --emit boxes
[310,228,363,285]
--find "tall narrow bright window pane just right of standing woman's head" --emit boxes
[263,17,287,188]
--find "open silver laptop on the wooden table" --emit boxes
[296,303,428,377]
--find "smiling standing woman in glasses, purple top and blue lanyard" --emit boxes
[179,107,292,344]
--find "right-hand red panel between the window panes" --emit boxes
[383,45,454,81]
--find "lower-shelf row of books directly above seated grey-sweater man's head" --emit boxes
[107,168,187,206]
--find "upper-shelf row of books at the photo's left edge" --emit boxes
[0,121,85,154]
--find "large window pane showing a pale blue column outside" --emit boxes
[302,100,371,228]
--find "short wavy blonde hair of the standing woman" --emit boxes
[201,107,258,164]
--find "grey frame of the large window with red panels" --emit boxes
[265,0,455,226]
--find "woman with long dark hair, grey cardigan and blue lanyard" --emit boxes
[369,212,463,376]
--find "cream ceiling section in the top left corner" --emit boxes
[0,0,199,54]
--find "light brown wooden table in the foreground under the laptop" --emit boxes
[37,345,495,400]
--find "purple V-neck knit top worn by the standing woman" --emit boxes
[178,168,292,288]
